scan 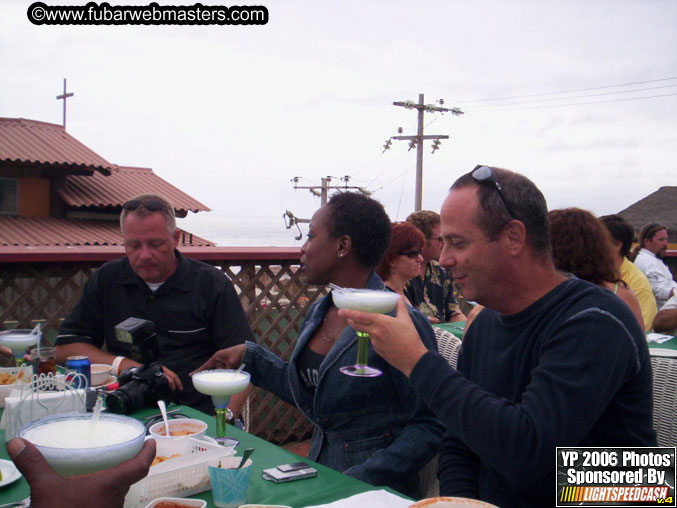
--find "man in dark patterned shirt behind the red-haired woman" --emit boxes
[404,210,465,323]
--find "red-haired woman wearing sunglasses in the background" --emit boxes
[376,222,425,305]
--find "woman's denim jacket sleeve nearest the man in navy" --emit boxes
[344,308,444,492]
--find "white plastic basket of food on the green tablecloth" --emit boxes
[124,438,235,508]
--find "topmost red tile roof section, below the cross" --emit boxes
[0,118,116,174]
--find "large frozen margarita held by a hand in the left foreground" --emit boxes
[18,413,146,476]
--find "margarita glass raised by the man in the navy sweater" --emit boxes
[331,288,400,377]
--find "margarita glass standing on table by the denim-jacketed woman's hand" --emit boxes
[193,369,250,446]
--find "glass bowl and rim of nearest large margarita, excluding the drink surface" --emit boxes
[18,413,146,476]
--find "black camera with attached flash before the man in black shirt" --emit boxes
[106,318,174,415]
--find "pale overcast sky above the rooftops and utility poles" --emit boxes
[0,0,677,228]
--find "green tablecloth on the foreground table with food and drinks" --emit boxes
[0,406,404,508]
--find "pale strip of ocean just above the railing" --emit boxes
[176,213,308,247]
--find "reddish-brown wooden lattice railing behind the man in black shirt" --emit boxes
[0,247,325,444]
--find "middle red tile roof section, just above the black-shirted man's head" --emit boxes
[63,166,210,217]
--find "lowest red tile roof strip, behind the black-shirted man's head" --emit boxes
[0,216,214,247]
